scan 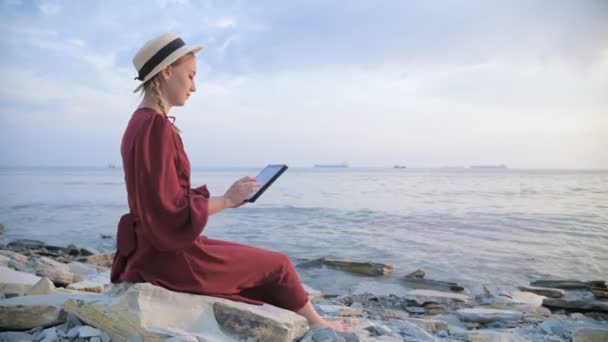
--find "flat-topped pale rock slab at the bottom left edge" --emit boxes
[0,294,100,330]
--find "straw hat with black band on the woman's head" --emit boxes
[133,33,203,93]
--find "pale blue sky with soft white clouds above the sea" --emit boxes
[0,0,608,169]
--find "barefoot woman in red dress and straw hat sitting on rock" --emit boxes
[112,33,346,331]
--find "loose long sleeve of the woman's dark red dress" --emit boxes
[133,115,209,251]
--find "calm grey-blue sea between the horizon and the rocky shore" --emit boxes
[0,166,608,294]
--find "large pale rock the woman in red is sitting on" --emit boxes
[65,283,308,341]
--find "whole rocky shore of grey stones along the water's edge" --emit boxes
[0,240,608,342]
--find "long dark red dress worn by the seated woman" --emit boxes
[111,108,308,311]
